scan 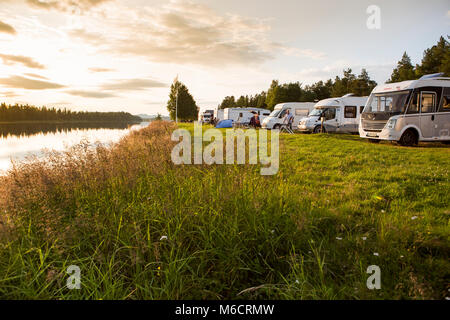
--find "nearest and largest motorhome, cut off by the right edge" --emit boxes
[359,73,450,146]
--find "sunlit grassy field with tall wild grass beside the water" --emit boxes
[0,122,450,299]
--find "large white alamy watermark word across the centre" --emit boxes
[171,123,280,175]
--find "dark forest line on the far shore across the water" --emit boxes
[0,103,142,123]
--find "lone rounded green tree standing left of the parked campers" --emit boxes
[167,81,199,120]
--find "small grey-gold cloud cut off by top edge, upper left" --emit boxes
[26,0,110,13]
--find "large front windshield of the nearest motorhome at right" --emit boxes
[363,91,410,114]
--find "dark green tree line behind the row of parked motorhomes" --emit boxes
[218,37,450,110]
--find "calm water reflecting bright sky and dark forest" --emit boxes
[0,122,148,175]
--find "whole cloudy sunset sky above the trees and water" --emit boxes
[0,0,450,115]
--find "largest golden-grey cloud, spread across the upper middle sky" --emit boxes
[64,1,324,67]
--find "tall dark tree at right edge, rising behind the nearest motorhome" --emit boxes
[416,37,450,77]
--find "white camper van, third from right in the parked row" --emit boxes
[261,102,314,130]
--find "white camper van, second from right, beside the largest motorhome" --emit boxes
[298,93,367,133]
